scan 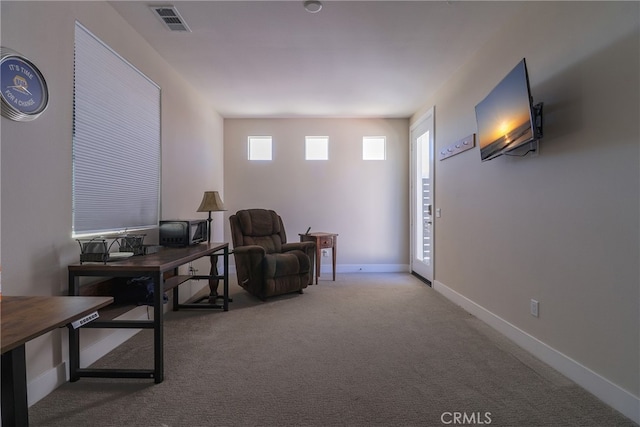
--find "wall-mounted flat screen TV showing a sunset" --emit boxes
[476,59,542,162]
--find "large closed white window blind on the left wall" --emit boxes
[73,23,161,237]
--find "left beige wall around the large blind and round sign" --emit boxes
[0,1,223,402]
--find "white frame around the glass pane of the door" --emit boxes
[409,107,435,283]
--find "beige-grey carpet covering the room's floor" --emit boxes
[30,274,636,427]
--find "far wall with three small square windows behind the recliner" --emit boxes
[224,119,409,271]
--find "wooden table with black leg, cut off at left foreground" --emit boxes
[0,295,113,426]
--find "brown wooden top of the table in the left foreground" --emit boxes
[0,295,113,354]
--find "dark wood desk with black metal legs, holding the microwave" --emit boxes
[68,242,229,383]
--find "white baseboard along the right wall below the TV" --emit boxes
[433,280,640,424]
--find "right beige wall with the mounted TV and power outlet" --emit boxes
[413,2,640,421]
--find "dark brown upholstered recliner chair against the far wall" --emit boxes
[229,209,315,300]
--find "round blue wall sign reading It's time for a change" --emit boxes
[0,47,49,121]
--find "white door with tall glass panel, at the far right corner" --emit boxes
[410,108,434,282]
